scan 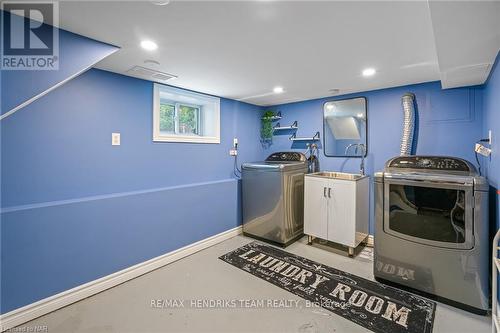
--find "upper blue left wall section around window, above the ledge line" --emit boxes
[2,70,260,208]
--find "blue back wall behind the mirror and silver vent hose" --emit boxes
[268,82,483,234]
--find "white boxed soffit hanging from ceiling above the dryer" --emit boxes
[429,0,500,88]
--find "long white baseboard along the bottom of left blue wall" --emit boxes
[0,226,242,332]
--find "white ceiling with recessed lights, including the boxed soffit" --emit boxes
[60,1,500,105]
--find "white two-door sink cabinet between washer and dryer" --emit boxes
[304,172,370,255]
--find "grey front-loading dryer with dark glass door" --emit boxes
[374,156,489,314]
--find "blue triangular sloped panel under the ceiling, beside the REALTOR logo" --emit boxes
[0,13,118,114]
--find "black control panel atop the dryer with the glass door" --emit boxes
[387,156,475,173]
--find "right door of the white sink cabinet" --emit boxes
[328,180,356,247]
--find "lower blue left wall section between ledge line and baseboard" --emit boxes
[1,180,239,313]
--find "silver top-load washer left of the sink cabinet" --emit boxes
[241,152,308,246]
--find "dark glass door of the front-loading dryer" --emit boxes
[384,179,474,249]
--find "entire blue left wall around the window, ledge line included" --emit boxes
[1,70,263,313]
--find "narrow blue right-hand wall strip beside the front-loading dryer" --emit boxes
[482,55,500,228]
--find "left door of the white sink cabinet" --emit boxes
[304,177,328,239]
